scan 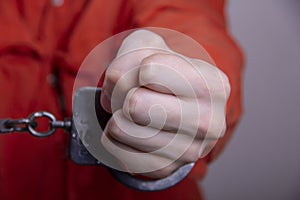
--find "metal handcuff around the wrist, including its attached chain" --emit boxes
[0,87,194,191]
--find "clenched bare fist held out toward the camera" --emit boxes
[101,30,230,178]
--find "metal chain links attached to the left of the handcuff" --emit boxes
[0,111,71,137]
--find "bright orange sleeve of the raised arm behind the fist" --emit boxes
[131,0,243,178]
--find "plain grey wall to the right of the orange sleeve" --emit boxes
[201,0,300,200]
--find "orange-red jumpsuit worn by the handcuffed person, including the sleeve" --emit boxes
[0,0,243,200]
